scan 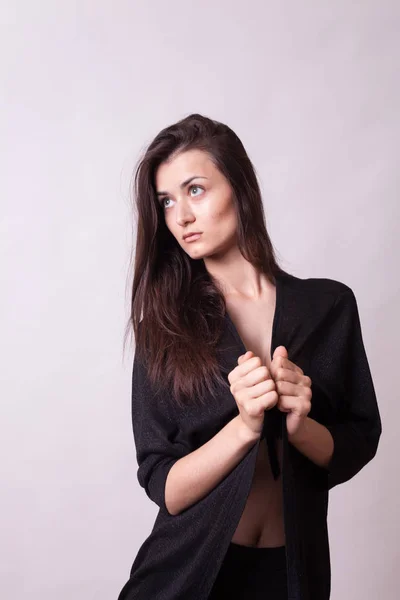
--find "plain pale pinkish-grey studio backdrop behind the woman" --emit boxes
[0,0,400,600]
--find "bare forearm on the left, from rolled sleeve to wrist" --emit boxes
[165,415,259,515]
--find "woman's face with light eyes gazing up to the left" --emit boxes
[155,150,237,259]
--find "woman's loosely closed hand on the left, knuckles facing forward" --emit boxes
[228,350,278,436]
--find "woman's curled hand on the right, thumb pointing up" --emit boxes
[270,346,312,436]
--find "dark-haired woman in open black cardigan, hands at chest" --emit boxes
[119,114,381,600]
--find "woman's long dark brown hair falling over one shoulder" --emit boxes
[124,114,282,406]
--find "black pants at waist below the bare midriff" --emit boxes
[208,542,288,600]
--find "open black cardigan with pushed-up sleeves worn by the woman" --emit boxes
[119,272,382,600]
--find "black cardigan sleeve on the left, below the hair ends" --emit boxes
[132,352,188,512]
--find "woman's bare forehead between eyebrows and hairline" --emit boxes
[155,150,216,189]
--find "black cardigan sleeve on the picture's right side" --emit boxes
[326,288,382,489]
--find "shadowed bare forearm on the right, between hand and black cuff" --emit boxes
[288,417,334,468]
